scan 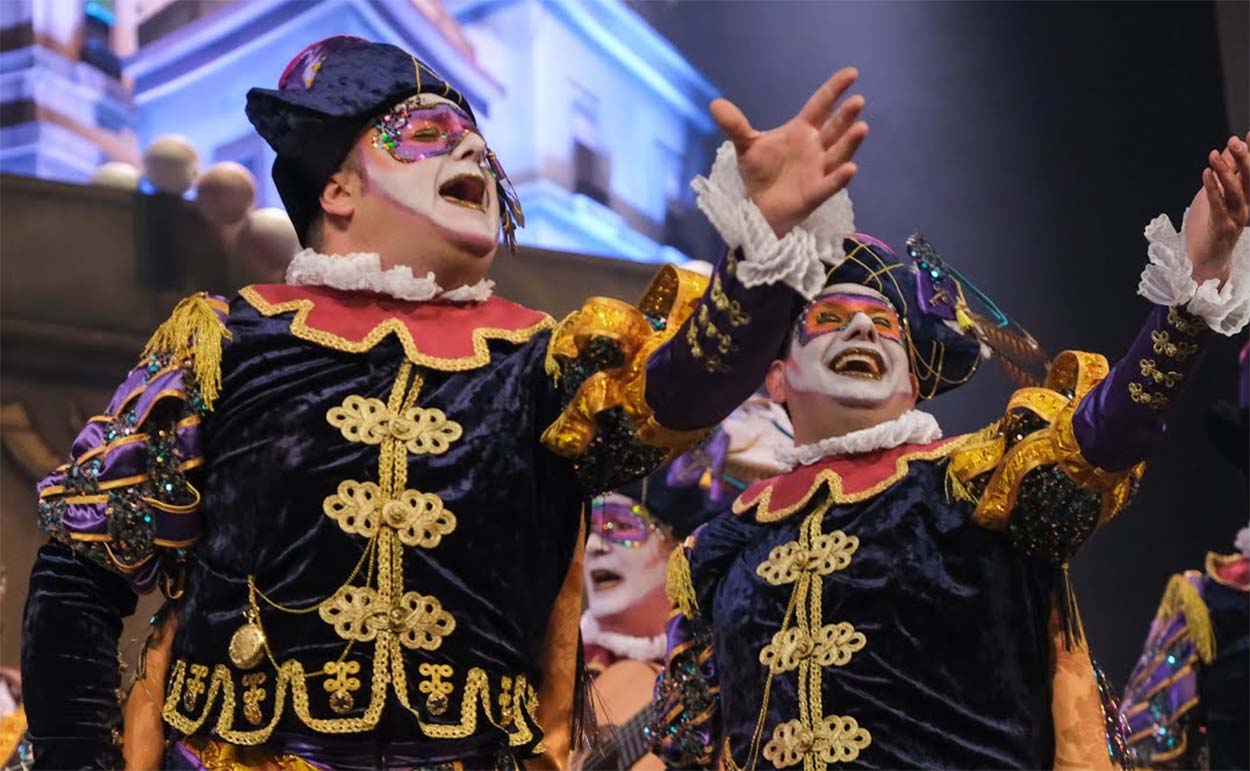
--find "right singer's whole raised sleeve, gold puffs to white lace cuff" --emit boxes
[949,207,1250,564]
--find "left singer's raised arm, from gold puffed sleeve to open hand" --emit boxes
[544,67,868,492]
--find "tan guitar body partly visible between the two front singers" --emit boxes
[575,659,664,771]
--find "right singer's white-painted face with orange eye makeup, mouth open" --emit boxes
[785,284,911,407]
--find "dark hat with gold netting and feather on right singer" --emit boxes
[825,234,1045,399]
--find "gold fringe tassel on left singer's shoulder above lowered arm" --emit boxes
[143,292,230,410]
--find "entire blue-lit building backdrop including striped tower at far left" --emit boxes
[0,0,715,262]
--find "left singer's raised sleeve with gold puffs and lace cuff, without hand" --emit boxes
[543,142,854,494]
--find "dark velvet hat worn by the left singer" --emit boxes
[248,35,480,245]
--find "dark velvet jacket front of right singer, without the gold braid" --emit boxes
[690,461,1054,769]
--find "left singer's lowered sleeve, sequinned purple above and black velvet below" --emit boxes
[23,295,228,769]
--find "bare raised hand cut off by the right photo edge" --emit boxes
[1185,134,1250,284]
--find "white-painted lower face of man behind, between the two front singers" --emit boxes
[583,492,671,619]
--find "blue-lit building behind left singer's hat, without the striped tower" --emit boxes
[126,0,715,262]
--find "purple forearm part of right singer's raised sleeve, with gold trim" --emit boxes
[1073,306,1211,471]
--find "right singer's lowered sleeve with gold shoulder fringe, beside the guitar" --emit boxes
[648,536,724,769]
